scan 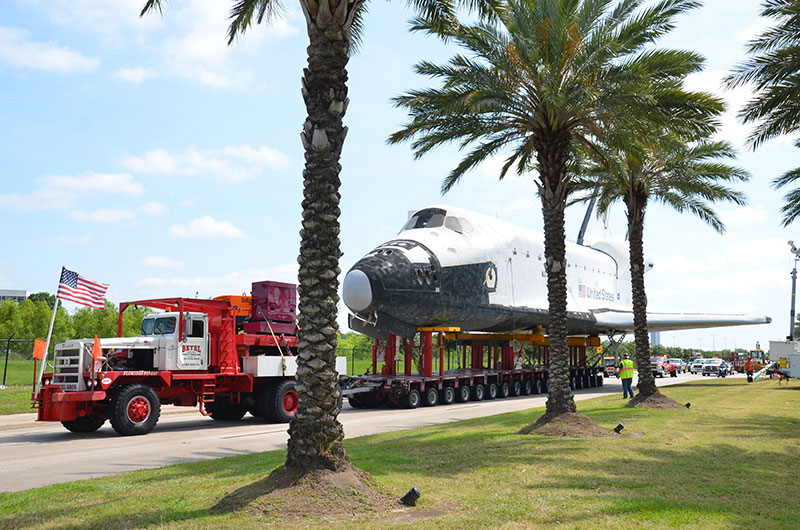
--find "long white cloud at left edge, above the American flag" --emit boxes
[0,173,144,211]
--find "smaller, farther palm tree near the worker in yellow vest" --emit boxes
[575,131,749,396]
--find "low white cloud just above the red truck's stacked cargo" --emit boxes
[136,262,298,298]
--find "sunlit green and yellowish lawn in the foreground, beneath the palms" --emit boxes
[0,380,800,529]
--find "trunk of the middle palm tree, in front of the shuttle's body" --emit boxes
[535,131,577,415]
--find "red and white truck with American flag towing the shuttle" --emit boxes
[33,281,347,435]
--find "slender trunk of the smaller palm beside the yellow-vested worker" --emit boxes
[626,197,658,399]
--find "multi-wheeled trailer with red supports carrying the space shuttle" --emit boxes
[341,328,603,408]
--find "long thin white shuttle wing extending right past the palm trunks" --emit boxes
[593,310,772,331]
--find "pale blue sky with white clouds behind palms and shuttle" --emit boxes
[0,0,800,350]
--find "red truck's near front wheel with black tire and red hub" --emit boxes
[108,383,161,436]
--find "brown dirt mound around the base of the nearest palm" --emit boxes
[211,465,447,526]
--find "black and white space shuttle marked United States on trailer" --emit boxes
[342,206,771,338]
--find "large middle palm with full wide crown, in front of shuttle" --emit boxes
[389,0,701,421]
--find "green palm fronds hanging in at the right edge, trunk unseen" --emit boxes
[726,0,800,226]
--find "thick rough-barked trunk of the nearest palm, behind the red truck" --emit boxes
[286,0,360,472]
